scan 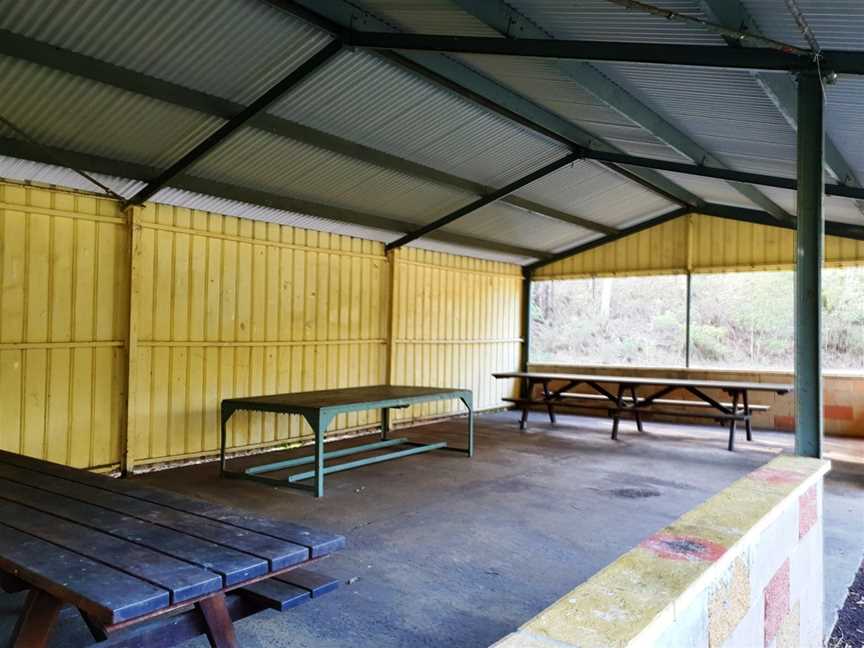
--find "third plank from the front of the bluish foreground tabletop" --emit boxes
[0,474,267,586]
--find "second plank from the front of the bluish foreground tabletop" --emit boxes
[0,493,222,603]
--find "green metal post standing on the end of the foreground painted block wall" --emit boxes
[795,71,825,457]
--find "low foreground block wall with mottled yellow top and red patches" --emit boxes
[495,456,830,648]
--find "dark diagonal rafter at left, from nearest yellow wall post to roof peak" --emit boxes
[126,40,343,205]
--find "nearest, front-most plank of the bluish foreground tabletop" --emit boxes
[0,524,171,624]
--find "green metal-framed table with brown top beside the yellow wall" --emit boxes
[219,385,474,497]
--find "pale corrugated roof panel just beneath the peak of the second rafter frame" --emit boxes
[517,161,675,227]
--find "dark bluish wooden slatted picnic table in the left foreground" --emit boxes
[0,451,345,648]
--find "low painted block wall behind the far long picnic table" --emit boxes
[530,364,864,438]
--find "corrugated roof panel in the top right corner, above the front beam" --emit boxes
[742,0,864,50]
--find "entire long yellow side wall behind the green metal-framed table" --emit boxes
[0,183,522,469]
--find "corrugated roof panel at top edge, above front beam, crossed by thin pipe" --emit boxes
[510,0,723,45]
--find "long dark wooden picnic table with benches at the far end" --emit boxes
[492,371,794,451]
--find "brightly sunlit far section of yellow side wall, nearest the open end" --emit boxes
[391,248,523,422]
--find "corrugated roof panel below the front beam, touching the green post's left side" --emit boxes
[598,64,795,175]
